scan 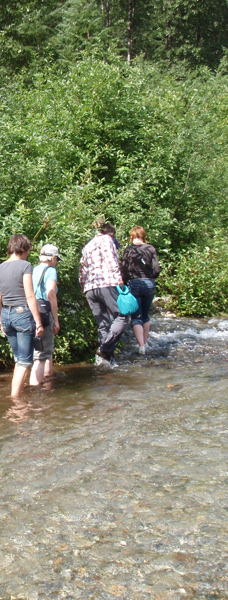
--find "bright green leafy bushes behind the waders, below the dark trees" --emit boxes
[0,56,228,362]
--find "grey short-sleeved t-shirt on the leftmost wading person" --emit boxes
[0,258,32,306]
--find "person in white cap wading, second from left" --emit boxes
[30,244,61,385]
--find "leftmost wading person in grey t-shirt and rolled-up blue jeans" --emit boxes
[0,234,44,398]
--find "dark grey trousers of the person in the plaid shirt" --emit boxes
[86,286,128,357]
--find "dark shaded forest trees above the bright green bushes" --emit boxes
[0,0,228,72]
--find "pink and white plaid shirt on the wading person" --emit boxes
[79,233,122,292]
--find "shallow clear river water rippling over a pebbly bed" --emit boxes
[0,317,228,600]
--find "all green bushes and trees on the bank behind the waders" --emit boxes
[0,0,228,364]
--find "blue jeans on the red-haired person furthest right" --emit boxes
[129,279,155,325]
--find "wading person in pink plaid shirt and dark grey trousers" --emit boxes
[79,223,128,366]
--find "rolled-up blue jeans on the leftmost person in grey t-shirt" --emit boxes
[2,306,36,367]
